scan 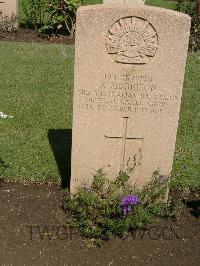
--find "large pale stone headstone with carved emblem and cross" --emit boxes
[71,4,190,193]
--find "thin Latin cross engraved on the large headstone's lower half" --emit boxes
[104,116,144,171]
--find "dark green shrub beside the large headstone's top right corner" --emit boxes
[176,0,200,52]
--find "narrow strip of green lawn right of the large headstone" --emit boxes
[171,52,200,189]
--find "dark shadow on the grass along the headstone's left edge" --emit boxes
[48,129,72,188]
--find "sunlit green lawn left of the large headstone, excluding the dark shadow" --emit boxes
[0,43,74,185]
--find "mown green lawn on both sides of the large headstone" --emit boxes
[0,43,200,191]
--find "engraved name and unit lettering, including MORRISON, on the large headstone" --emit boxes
[78,74,177,114]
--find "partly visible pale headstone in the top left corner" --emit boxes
[0,0,18,31]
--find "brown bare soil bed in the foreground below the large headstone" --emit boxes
[0,183,200,266]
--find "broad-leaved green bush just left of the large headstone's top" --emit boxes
[40,0,82,36]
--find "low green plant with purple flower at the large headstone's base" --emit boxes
[64,169,173,243]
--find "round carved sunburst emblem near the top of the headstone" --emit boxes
[106,17,158,64]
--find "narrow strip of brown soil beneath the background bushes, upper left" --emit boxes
[0,28,74,45]
